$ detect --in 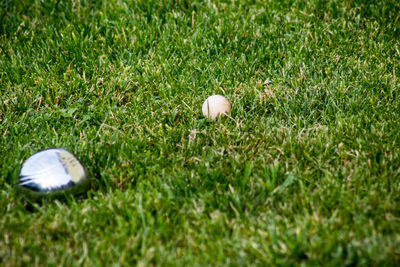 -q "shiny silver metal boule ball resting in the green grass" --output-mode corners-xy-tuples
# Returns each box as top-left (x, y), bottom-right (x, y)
(18, 148), (87, 195)
